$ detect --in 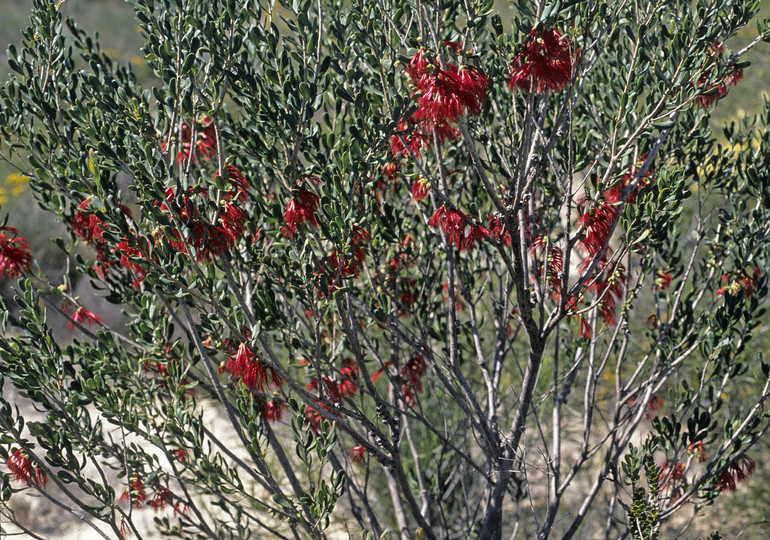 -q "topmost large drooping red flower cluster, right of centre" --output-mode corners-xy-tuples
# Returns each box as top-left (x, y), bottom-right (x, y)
(508, 30), (572, 94)
